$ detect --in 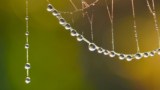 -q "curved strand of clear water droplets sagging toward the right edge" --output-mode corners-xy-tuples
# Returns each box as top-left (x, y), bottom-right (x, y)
(47, 4), (160, 61)
